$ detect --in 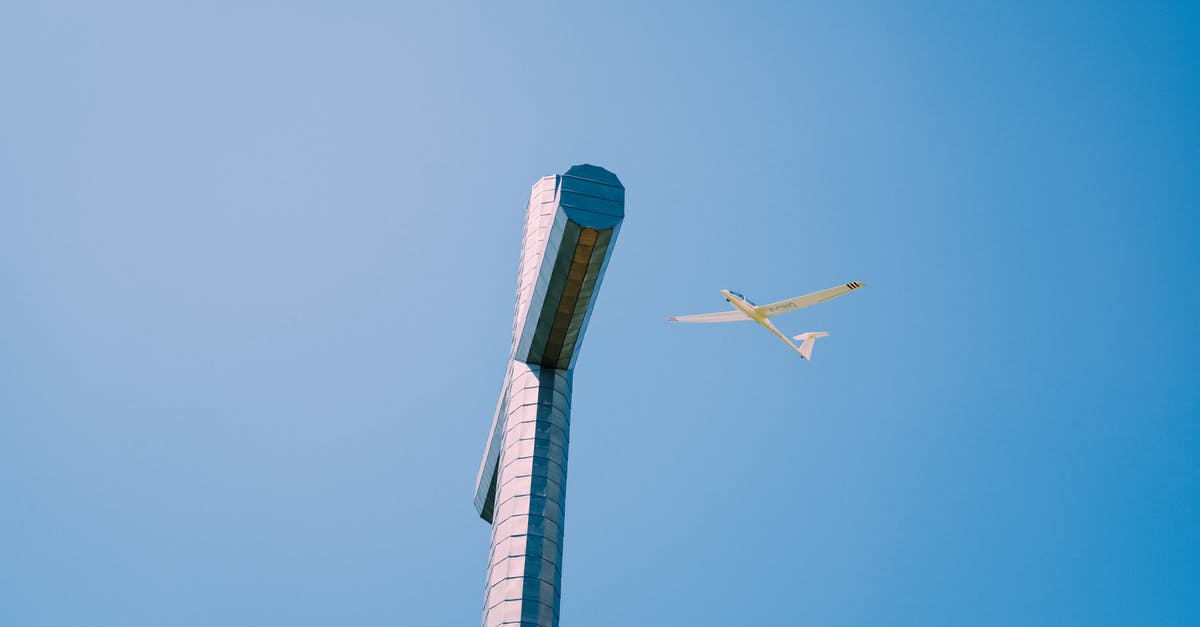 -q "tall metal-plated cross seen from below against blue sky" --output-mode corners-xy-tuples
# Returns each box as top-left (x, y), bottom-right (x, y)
(475, 165), (625, 627)
